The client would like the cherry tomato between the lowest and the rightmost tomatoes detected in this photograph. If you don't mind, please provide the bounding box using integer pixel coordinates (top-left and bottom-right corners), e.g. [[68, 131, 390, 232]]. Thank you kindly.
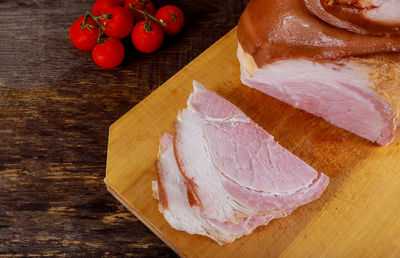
[[132, 21, 164, 53]]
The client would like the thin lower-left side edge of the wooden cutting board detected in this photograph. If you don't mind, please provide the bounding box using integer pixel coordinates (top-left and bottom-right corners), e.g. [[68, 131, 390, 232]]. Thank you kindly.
[[104, 177, 186, 257]]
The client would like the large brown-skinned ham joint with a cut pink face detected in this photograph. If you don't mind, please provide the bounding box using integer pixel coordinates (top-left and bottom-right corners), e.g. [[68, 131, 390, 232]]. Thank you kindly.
[[238, 0, 400, 145]]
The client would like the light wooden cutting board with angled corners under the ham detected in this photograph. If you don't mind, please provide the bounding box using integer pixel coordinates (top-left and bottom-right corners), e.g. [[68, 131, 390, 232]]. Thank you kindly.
[[105, 29, 400, 257]]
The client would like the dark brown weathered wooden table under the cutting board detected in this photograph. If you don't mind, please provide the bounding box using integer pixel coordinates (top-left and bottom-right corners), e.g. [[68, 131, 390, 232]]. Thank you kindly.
[[0, 0, 248, 257]]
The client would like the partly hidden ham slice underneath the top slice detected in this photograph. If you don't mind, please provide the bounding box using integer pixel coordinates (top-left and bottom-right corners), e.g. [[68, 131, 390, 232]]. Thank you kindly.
[[153, 133, 292, 245]]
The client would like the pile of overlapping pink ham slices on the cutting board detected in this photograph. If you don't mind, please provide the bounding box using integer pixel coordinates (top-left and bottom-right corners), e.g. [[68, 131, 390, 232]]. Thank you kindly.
[[153, 82, 329, 244]]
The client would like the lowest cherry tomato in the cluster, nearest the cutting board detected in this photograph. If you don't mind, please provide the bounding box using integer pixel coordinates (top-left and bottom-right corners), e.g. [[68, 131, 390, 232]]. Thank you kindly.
[[92, 38, 125, 69]]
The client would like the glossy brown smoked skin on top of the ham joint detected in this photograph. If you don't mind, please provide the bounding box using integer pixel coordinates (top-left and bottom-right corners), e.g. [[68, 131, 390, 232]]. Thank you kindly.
[[237, 0, 400, 65]]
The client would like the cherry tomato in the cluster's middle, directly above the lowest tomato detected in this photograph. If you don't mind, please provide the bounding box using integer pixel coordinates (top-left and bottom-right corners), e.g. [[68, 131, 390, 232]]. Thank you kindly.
[[101, 6, 134, 39]]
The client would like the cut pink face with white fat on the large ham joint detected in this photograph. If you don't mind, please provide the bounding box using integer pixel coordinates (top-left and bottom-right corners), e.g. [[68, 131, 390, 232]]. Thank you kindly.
[[238, 45, 395, 145]]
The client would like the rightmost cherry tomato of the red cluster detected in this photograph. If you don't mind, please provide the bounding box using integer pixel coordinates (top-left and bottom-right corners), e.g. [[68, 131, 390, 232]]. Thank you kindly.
[[156, 5, 185, 35]]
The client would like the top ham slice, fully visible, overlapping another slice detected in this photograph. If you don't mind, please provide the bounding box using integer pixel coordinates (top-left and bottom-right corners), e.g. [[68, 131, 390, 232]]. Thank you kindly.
[[173, 82, 329, 224]]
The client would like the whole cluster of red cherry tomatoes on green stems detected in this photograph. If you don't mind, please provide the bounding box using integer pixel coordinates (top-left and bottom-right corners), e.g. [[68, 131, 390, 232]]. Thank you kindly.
[[69, 0, 184, 68]]
